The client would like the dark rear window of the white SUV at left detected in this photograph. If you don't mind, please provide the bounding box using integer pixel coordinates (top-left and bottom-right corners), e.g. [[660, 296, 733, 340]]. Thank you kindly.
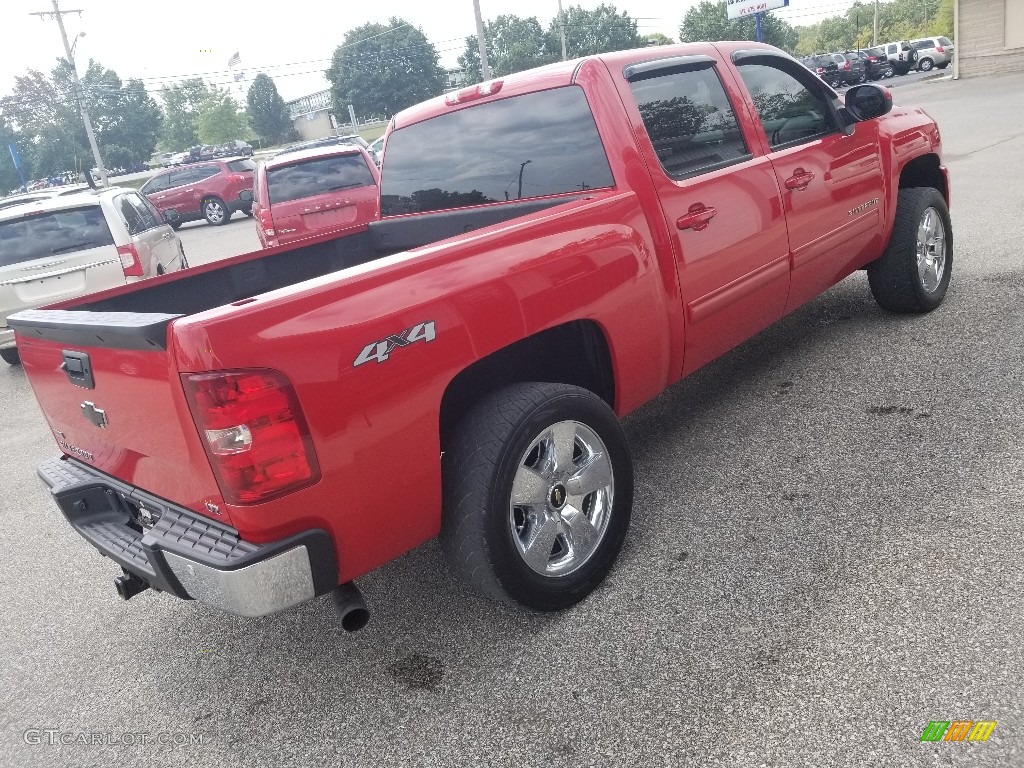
[[0, 206, 114, 266]]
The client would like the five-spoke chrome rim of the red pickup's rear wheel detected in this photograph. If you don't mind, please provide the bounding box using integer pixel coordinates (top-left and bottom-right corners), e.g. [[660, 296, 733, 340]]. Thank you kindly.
[[509, 421, 614, 577]]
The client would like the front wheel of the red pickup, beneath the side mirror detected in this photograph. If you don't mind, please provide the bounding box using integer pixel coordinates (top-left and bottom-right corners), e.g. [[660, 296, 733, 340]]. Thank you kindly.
[[867, 186, 953, 314]]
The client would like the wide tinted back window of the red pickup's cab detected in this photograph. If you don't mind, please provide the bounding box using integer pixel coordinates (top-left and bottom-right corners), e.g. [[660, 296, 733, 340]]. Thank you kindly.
[[381, 85, 614, 216]]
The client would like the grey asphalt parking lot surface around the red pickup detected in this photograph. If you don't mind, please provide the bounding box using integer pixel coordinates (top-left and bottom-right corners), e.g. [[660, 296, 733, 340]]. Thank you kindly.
[[0, 75, 1024, 768]]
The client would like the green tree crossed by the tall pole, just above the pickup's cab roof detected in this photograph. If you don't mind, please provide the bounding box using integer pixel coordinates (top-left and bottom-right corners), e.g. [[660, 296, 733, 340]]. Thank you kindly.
[[459, 15, 558, 83]]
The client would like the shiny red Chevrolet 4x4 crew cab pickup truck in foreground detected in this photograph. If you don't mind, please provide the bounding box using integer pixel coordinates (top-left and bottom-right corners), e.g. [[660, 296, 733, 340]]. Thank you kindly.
[[9, 43, 952, 630]]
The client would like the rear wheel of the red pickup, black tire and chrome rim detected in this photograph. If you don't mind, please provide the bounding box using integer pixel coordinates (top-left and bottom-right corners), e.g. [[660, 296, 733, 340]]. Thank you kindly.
[[440, 383, 633, 611]]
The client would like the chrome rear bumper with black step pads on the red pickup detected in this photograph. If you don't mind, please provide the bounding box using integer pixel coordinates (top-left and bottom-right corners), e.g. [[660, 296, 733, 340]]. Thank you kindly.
[[38, 458, 338, 616]]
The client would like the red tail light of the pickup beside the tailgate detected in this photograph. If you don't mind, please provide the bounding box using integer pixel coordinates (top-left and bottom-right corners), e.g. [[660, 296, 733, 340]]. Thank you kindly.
[[181, 370, 321, 504]]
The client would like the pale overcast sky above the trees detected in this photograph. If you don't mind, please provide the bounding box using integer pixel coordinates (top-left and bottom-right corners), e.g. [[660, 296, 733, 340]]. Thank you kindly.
[[0, 0, 852, 100]]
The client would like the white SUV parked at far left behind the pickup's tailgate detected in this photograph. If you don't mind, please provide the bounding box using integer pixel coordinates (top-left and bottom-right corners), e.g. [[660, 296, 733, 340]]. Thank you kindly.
[[0, 187, 188, 366]]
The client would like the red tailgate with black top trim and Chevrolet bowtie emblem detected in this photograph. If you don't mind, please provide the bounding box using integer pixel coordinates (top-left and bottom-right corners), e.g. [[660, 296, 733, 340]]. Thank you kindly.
[[8, 309, 229, 523]]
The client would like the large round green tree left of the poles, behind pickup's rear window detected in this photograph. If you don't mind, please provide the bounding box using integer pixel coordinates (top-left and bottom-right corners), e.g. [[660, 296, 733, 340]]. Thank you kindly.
[[325, 16, 444, 116]]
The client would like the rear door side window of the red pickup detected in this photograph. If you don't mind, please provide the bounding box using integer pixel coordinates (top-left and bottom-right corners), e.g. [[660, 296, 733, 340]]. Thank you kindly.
[[630, 68, 751, 180]]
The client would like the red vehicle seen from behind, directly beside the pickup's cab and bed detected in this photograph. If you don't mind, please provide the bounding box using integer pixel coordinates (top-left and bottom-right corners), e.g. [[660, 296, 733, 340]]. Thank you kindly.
[[253, 144, 380, 248]]
